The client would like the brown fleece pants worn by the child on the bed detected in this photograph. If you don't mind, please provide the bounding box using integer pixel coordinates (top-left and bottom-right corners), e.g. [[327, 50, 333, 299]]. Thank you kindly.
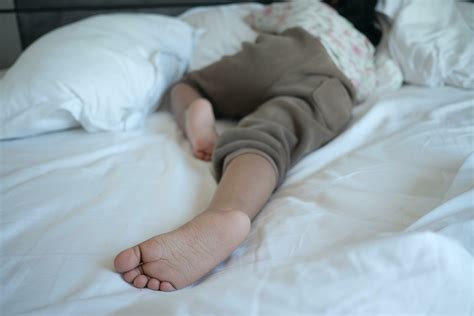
[[182, 28, 354, 184]]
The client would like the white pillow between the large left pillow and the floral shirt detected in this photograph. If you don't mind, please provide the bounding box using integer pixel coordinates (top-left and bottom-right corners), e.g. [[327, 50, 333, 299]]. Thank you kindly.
[[180, 3, 263, 71]]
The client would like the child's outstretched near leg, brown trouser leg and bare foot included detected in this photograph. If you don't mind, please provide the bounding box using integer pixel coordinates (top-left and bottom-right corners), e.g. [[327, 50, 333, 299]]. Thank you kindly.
[[115, 74, 352, 291]]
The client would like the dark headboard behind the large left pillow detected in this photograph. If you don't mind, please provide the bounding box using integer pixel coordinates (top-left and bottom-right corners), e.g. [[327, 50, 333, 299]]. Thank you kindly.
[[0, 0, 274, 69]]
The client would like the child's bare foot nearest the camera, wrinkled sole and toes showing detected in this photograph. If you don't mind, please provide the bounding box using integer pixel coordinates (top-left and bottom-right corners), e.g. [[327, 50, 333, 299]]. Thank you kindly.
[[114, 211, 250, 291]]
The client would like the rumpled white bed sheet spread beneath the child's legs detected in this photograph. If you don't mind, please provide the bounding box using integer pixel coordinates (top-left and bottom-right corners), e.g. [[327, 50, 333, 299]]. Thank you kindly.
[[0, 86, 474, 315]]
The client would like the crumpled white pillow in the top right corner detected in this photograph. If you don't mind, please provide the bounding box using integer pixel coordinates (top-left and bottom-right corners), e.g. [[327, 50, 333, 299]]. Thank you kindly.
[[377, 0, 474, 89]]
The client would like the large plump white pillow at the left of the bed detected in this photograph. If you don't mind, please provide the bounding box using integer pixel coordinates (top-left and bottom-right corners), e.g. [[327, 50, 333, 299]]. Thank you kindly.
[[0, 14, 196, 139]]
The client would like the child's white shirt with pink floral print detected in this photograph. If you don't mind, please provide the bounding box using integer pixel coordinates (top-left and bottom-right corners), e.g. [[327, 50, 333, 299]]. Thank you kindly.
[[248, 0, 376, 102]]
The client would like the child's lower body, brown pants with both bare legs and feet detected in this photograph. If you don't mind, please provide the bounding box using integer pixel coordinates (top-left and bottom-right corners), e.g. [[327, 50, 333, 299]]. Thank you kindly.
[[114, 0, 382, 291]]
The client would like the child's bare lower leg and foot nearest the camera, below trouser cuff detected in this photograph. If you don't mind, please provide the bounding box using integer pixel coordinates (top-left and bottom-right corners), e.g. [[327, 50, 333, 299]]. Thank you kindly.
[[114, 153, 277, 291]]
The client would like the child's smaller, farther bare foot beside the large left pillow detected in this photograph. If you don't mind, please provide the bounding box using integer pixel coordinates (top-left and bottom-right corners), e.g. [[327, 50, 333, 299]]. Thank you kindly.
[[184, 98, 217, 161]]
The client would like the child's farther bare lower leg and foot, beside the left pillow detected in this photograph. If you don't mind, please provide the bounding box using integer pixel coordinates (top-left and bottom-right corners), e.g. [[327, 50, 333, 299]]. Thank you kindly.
[[171, 83, 217, 160]]
